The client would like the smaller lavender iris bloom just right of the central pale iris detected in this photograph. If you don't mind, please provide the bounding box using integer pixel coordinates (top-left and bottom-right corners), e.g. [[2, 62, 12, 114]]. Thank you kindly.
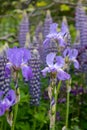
[[63, 48, 79, 69]]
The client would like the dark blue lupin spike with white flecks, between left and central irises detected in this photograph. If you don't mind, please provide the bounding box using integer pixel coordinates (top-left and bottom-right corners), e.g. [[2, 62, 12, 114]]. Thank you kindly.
[[29, 49, 41, 106]]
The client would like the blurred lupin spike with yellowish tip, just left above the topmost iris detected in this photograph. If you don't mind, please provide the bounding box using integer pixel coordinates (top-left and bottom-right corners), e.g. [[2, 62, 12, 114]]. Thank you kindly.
[[43, 10, 53, 39]]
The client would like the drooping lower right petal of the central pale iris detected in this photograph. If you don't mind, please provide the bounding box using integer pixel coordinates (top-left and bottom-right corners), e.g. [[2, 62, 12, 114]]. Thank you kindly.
[[57, 69, 70, 80]]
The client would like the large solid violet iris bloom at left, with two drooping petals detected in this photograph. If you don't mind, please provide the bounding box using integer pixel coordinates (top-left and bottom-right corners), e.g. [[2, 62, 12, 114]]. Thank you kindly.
[[5, 47, 32, 80]]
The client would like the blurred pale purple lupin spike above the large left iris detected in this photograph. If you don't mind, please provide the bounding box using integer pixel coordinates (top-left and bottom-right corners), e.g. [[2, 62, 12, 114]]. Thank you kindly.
[[18, 12, 29, 47]]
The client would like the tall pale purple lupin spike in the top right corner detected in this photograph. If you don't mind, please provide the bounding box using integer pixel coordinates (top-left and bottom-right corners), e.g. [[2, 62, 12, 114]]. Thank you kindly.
[[75, 2, 87, 45]]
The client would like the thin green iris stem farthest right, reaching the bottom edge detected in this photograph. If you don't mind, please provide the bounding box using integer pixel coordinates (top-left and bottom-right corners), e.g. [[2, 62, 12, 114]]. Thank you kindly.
[[66, 80, 70, 130]]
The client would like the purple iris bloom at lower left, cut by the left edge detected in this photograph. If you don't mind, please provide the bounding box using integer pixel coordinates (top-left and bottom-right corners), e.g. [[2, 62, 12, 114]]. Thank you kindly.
[[0, 89, 16, 116]]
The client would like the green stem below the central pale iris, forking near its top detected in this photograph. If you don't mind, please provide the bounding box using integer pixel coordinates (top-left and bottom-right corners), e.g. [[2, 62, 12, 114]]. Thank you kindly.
[[51, 81, 61, 130]]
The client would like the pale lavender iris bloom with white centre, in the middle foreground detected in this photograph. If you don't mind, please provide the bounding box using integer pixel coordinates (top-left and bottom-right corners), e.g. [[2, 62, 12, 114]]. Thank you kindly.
[[42, 53, 70, 80]]
